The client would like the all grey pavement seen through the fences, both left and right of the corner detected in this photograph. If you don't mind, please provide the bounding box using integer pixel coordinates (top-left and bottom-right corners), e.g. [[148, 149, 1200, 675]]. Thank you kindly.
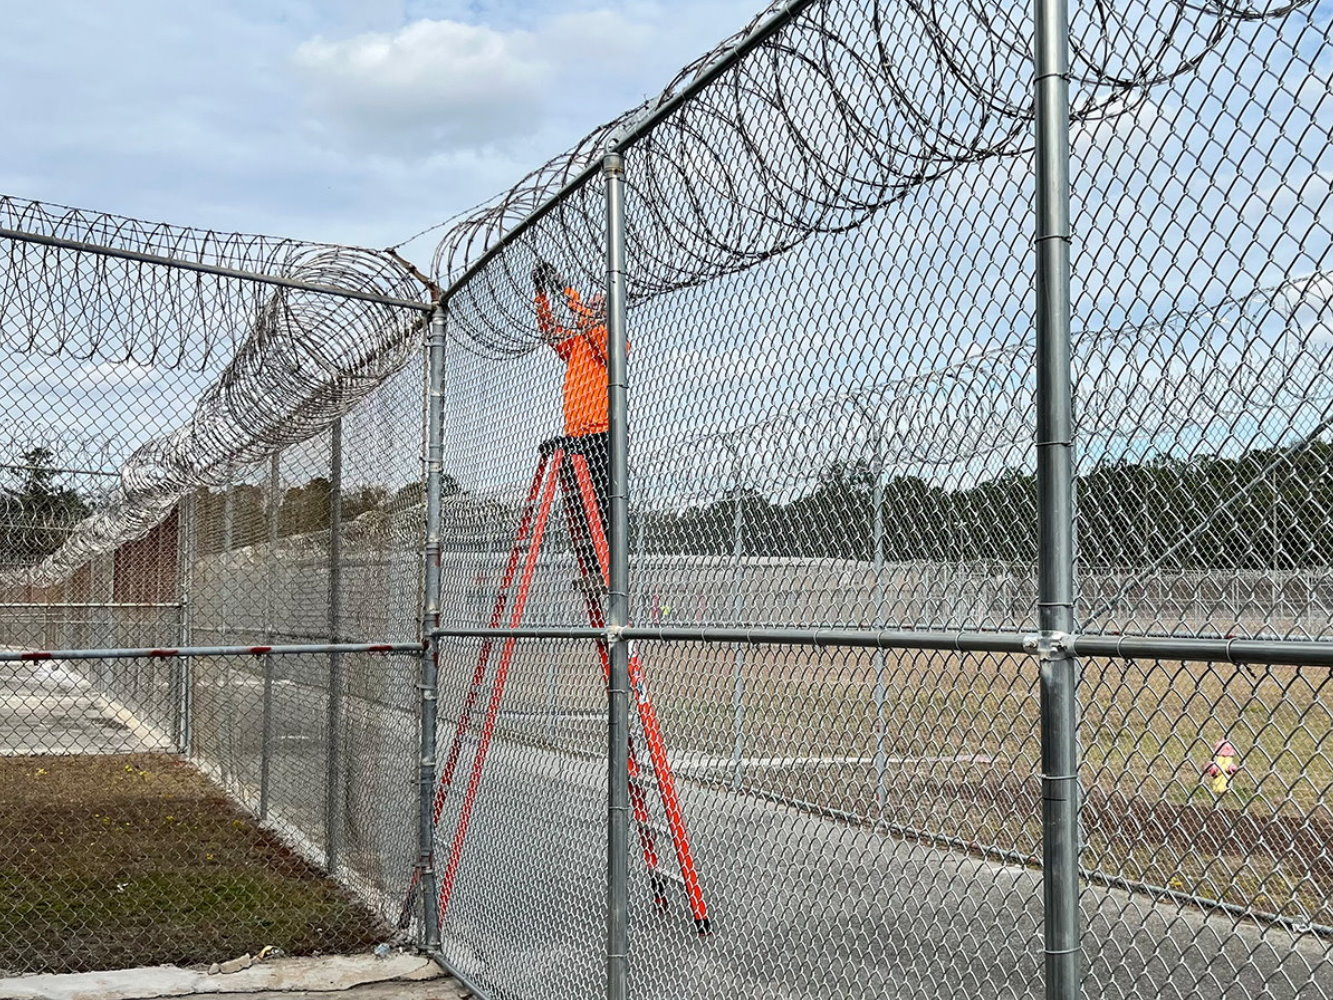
[[0, 657, 1333, 1000]]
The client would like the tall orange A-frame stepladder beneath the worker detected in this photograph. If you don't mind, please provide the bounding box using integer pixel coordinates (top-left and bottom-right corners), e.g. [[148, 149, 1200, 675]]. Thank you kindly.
[[399, 437, 709, 933]]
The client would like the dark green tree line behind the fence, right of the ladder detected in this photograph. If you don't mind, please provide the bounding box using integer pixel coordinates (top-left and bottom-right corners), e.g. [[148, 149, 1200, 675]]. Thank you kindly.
[[635, 441, 1333, 569]]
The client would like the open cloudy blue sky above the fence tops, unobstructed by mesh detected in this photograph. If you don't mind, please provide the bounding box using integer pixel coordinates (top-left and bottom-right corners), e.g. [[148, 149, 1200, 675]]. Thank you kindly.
[[0, 0, 761, 263]]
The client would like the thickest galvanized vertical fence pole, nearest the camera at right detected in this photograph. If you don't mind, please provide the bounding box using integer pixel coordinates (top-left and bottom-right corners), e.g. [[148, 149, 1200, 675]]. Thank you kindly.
[[1033, 0, 1082, 1000]]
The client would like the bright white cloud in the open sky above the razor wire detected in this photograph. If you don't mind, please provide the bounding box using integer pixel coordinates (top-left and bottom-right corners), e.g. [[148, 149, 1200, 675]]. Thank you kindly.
[[293, 0, 748, 157]]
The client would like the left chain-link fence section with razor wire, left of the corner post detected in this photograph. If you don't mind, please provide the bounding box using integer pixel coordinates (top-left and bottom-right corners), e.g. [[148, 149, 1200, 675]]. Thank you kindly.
[[0, 199, 424, 975]]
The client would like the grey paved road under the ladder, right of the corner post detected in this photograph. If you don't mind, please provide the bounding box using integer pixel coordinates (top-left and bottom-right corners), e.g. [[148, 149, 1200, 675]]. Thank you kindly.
[[440, 741, 1333, 1000]]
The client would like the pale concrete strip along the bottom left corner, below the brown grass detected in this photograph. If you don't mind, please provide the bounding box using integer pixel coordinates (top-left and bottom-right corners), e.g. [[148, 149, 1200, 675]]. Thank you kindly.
[[0, 953, 471, 1000]]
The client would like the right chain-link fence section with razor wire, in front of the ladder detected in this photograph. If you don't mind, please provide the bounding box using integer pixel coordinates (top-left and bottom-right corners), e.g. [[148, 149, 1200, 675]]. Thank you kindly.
[[418, 1, 1333, 999]]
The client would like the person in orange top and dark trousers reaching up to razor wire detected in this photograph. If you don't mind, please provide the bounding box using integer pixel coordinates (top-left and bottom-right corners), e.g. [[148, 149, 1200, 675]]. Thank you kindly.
[[532, 263, 611, 596]]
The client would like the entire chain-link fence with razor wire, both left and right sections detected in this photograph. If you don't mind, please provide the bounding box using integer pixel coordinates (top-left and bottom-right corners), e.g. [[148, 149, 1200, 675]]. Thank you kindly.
[[0, 0, 1333, 1000]]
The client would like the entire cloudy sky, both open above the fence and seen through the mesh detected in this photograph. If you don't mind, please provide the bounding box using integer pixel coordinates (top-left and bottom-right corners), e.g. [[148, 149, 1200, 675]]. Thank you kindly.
[[0, 0, 1333, 594]]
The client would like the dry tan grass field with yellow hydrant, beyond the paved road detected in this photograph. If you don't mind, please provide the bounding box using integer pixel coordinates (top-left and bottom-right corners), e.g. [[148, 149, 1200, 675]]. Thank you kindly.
[[461, 643, 1333, 924]]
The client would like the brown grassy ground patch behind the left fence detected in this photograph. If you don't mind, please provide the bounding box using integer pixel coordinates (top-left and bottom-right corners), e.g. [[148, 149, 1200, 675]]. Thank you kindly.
[[0, 753, 389, 975]]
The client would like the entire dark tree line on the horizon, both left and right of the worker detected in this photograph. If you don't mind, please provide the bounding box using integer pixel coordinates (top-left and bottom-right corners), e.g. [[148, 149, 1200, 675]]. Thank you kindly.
[[0, 441, 1333, 569]]
